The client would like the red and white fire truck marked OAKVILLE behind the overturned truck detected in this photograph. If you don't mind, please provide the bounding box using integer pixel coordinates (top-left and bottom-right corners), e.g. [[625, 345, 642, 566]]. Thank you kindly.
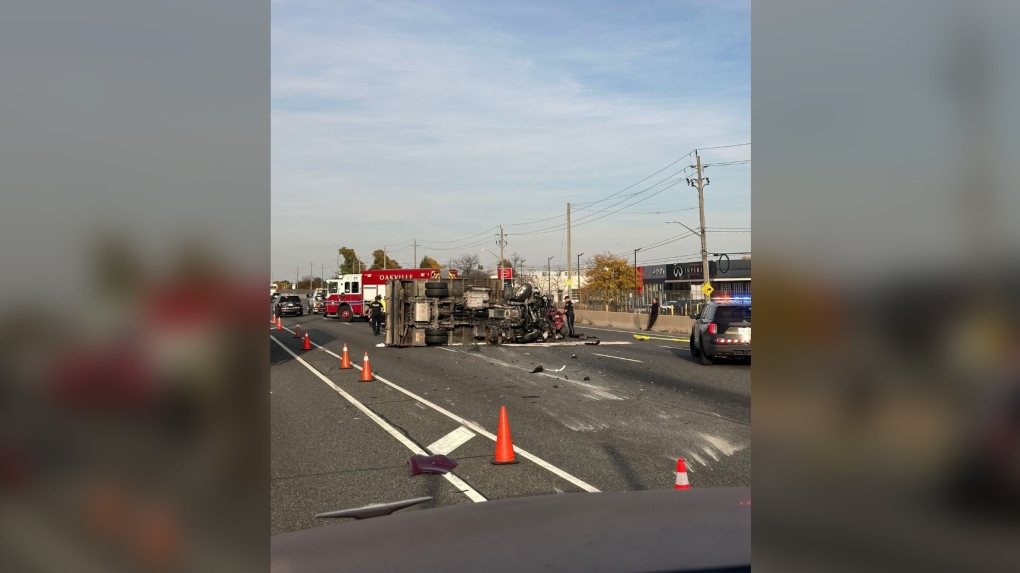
[[322, 268, 457, 322]]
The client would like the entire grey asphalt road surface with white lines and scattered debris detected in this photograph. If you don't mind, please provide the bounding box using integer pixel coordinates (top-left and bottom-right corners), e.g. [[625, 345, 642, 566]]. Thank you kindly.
[[269, 315, 751, 534]]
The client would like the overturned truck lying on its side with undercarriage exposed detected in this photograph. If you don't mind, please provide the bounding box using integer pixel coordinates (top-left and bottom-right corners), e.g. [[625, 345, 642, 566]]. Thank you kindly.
[[386, 278, 568, 347]]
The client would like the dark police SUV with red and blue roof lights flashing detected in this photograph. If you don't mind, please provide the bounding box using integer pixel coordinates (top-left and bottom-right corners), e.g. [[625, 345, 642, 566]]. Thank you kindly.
[[691, 301, 751, 366]]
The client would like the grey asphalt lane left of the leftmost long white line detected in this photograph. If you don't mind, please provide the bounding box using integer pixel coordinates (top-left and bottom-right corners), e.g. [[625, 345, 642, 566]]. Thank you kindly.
[[269, 331, 470, 534]]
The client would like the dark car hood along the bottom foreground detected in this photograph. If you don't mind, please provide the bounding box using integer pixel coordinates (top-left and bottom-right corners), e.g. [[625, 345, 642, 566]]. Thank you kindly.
[[270, 487, 751, 573]]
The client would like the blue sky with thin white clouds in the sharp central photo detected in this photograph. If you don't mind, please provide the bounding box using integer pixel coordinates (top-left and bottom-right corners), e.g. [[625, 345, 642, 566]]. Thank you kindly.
[[271, 0, 751, 278]]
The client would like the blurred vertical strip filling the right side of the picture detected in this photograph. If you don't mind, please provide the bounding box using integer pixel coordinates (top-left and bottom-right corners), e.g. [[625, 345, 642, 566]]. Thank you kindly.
[[753, 0, 1020, 571]]
